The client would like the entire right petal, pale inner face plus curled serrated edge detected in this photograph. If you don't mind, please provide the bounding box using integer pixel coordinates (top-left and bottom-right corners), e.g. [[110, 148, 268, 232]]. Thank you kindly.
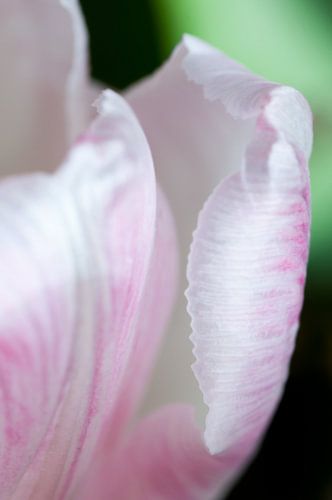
[[128, 36, 312, 498]]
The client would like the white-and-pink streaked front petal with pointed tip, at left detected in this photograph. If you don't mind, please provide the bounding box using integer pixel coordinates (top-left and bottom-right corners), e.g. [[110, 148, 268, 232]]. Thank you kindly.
[[0, 91, 167, 500]]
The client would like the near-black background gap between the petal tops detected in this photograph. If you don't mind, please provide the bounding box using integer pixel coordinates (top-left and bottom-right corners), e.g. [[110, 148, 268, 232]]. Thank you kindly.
[[80, 0, 161, 89]]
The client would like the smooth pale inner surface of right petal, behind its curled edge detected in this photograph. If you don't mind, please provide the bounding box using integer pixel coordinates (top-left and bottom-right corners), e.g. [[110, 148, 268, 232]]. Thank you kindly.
[[126, 36, 273, 421]]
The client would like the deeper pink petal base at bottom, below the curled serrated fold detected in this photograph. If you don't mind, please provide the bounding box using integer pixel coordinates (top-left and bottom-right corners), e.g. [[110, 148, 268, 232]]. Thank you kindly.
[[88, 405, 232, 500]]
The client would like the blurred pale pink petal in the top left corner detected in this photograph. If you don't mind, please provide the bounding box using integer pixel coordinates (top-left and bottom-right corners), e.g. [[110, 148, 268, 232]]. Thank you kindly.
[[0, 0, 91, 175]]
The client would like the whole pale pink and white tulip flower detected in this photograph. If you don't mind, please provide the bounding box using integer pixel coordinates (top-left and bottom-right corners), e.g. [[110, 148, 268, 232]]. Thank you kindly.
[[0, 0, 312, 500]]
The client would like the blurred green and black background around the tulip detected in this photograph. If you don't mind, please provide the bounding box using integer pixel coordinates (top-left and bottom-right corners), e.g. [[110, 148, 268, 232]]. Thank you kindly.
[[81, 0, 332, 500]]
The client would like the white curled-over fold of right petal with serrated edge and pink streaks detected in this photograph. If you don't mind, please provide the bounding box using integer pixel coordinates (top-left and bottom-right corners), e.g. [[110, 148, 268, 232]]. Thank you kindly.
[[187, 84, 310, 453]]
